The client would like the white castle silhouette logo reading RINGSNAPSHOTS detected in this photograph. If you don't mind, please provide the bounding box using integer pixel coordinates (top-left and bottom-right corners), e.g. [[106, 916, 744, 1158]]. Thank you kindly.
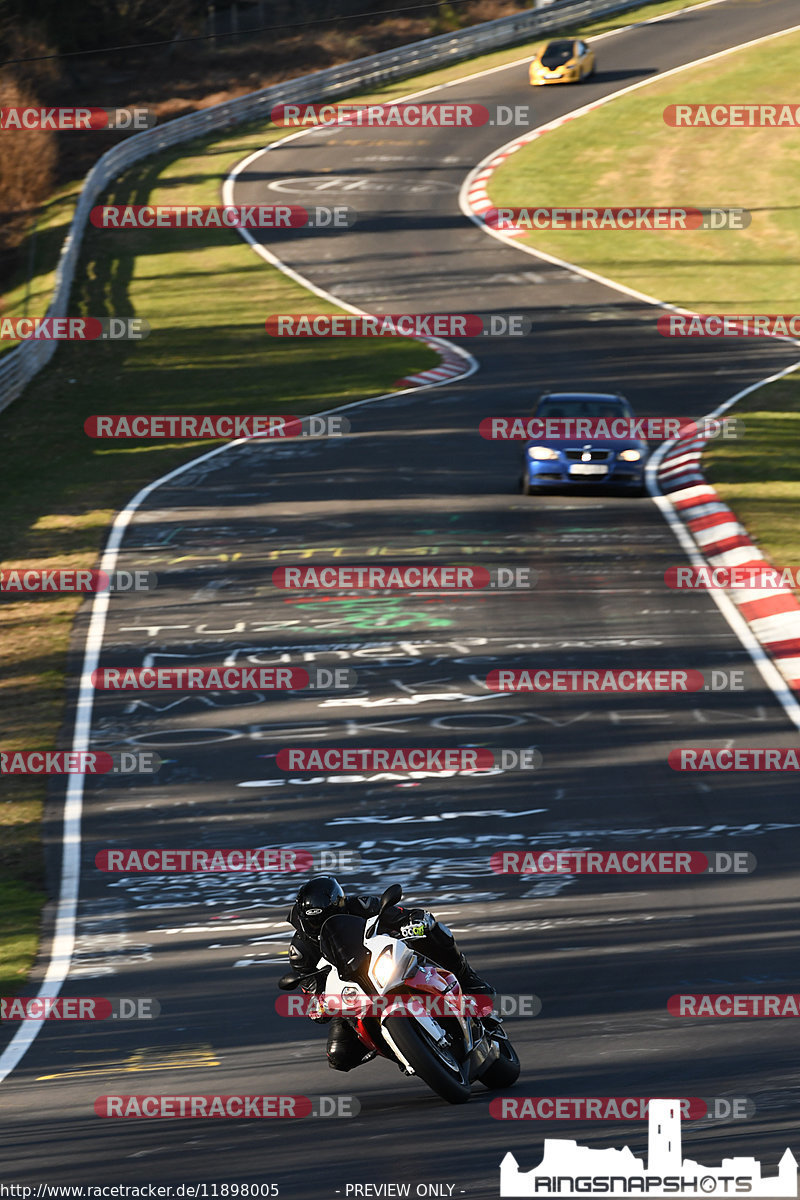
[[500, 1099, 798, 1200]]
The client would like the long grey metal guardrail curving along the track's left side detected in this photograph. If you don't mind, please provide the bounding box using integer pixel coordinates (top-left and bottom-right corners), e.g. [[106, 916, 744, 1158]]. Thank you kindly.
[[0, 0, 657, 412]]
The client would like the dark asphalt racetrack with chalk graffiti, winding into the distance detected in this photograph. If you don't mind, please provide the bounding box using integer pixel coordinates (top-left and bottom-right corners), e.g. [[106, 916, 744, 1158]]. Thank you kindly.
[[0, 0, 800, 1200]]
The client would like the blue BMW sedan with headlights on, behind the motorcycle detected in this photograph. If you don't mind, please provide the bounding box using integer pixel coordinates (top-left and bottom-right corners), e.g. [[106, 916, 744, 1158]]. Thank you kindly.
[[522, 391, 649, 496]]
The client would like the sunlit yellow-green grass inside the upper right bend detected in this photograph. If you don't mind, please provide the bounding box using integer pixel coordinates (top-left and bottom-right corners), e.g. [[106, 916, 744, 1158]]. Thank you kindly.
[[489, 34, 800, 313]]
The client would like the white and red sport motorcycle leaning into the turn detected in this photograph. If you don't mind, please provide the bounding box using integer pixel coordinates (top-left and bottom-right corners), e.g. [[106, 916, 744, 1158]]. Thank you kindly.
[[278, 883, 521, 1104]]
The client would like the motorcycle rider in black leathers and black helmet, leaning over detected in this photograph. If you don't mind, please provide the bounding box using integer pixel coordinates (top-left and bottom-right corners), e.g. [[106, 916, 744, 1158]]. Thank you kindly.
[[287, 875, 494, 1070]]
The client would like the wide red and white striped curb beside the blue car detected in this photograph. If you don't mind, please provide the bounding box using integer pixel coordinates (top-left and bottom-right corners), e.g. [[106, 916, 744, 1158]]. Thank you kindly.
[[656, 434, 800, 691]]
